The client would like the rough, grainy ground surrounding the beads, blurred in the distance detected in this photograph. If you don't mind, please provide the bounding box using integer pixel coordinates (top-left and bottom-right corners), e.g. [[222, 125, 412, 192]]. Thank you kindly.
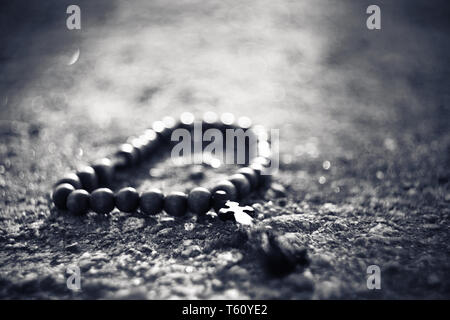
[[0, 0, 450, 299]]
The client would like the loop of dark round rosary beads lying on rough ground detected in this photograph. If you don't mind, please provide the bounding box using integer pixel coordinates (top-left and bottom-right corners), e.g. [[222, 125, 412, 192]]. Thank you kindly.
[[52, 112, 270, 217]]
